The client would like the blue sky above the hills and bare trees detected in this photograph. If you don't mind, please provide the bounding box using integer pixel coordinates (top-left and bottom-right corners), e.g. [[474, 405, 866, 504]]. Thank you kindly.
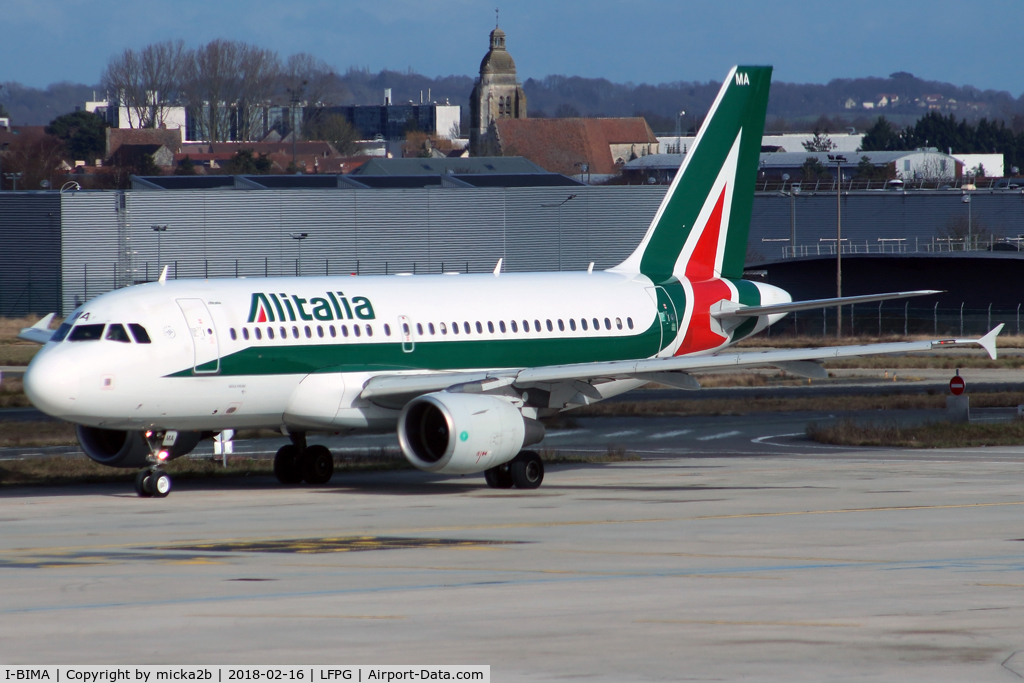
[[6, 0, 1024, 96]]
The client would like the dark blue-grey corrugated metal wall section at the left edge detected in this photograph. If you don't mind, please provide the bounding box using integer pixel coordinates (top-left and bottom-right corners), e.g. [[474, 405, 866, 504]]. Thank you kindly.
[[0, 191, 60, 316]]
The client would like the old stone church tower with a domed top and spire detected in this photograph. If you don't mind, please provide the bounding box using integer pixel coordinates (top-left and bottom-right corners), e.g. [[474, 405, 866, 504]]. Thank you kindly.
[[469, 26, 526, 157]]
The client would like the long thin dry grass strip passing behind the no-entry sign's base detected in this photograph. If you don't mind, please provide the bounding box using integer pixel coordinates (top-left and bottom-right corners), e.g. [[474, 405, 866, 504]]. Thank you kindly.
[[572, 391, 1024, 418]]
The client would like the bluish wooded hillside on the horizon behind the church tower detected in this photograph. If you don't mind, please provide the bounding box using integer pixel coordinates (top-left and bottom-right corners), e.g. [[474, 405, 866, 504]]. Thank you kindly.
[[0, 70, 1024, 133]]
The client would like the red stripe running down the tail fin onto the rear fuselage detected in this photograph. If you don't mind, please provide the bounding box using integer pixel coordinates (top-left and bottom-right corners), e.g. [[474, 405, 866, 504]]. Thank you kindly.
[[676, 186, 732, 355]]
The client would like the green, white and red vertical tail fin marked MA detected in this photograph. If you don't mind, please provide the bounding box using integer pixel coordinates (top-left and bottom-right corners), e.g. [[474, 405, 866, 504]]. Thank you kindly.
[[612, 67, 772, 282]]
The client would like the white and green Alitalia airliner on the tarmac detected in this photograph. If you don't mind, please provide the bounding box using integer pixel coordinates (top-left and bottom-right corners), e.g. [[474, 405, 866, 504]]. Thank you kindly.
[[20, 67, 1001, 497]]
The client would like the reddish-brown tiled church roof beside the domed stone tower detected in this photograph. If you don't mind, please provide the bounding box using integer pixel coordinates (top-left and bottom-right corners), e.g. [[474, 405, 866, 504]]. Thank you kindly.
[[495, 117, 657, 175]]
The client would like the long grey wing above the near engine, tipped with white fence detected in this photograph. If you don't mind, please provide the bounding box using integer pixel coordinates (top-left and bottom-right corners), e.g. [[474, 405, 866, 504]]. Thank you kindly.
[[359, 325, 1004, 405]]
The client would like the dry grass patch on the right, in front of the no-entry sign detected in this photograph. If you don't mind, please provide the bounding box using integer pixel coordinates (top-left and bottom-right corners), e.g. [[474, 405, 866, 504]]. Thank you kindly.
[[807, 420, 1024, 449]]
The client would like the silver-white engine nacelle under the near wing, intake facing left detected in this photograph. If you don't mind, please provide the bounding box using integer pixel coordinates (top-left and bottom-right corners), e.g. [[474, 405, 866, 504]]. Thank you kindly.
[[398, 391, 544, 474]]
